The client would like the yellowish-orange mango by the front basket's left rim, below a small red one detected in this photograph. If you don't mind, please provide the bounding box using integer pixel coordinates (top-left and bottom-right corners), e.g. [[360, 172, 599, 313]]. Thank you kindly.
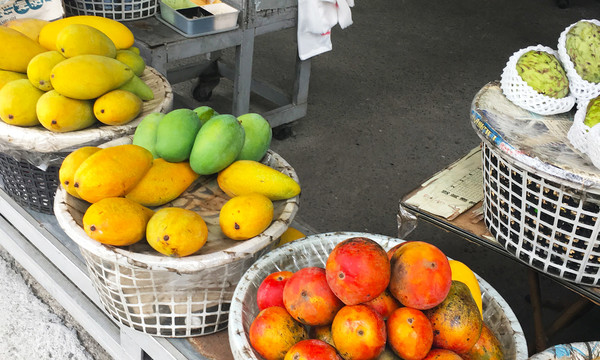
[[248, 306, 308, 360]]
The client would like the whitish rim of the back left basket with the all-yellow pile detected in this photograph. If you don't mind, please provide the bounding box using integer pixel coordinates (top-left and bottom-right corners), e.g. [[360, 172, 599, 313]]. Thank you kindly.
[[0, 66, 174, 153]]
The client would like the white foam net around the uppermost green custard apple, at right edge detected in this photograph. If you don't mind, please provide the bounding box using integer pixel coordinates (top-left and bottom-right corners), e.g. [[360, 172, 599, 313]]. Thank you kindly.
[[558, 20, 600, 101]]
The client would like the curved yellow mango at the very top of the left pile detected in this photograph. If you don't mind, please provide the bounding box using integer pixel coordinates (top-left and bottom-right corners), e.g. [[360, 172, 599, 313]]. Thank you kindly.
[[39, 15, 134, 50]]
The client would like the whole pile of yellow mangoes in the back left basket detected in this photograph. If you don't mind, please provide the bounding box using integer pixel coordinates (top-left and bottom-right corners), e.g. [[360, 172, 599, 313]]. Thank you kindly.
[[0, 15, 154, 132]]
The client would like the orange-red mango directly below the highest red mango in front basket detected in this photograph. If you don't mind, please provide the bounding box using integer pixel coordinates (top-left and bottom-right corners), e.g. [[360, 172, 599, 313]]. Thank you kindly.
[[331, 304, 387, 360]]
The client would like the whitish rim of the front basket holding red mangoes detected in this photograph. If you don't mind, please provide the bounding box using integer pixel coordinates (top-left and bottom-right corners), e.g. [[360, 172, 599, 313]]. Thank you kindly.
[[227, 231, 528, 359]]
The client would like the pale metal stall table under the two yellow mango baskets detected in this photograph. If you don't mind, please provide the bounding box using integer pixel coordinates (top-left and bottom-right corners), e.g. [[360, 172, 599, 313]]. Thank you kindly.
[[0, 189, 313, 360]]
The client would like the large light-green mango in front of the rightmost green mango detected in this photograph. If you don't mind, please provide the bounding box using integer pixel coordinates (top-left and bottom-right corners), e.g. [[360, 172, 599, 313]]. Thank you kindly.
[[190, 115, 245, 175]]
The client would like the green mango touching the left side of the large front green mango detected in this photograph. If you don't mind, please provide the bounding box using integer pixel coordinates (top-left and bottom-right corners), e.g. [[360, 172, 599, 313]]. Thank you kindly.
[[156, 109, 202, 162]]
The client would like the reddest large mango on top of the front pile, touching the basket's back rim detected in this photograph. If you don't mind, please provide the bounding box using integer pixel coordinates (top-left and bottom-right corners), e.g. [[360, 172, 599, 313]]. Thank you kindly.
[[325, 237, 390, 305]]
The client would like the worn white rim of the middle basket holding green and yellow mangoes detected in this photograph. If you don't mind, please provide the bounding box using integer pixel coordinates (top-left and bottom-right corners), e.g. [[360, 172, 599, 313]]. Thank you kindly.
[[54, 150, 300, 273]]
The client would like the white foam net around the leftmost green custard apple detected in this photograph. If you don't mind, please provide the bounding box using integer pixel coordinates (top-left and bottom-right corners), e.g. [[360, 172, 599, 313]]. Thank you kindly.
[[500, 45, 575, 115]]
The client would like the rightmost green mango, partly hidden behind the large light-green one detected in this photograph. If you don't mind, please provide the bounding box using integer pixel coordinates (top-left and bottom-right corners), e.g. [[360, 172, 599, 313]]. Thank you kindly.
[[236, 113, 273, 161]]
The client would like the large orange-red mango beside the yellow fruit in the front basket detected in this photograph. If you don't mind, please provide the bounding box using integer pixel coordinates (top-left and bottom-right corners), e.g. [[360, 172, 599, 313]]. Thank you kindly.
[[389, 241, 452, 310]]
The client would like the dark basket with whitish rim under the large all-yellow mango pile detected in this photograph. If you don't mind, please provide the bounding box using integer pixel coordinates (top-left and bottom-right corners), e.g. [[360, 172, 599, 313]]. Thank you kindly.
[[0, 67, 173, 214]]
